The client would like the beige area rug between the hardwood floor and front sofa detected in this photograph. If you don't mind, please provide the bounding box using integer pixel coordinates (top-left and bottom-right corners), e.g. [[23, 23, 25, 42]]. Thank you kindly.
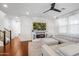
[[28, 41, 42, 56]]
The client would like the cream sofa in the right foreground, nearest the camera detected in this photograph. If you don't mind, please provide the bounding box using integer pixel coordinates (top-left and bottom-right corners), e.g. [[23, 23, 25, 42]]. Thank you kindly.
[[42, 43, 79, 56]]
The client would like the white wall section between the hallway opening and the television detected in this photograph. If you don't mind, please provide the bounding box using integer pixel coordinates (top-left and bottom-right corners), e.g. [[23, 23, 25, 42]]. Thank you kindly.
[[20, 17, 32, 41]]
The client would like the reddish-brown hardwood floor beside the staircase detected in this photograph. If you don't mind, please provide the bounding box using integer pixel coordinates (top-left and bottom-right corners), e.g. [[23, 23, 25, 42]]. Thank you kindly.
[[0, 37, 28, 56]]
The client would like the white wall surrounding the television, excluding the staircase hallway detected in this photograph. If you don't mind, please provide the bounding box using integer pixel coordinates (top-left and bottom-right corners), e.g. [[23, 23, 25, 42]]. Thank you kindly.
[[20, 17, 54, 41]]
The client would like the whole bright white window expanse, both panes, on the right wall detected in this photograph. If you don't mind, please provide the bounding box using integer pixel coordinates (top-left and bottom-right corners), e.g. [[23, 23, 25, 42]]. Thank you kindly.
[[56, 14, 79, 34]]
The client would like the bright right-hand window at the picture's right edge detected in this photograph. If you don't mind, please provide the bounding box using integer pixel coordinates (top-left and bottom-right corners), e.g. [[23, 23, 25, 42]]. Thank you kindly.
[[68, 14, 79, 34]]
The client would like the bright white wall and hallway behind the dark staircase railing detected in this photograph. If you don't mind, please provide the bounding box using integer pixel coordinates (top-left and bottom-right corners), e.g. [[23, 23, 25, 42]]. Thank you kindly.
[[0, 11, 20, 38]]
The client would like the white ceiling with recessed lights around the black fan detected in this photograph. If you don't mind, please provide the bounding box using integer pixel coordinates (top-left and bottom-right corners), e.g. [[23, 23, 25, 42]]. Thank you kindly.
[[0, 3, 79, 17]]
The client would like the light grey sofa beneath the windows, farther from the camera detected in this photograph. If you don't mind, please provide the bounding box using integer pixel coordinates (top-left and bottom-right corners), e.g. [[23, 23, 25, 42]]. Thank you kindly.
[[53, 35, 79, 43]]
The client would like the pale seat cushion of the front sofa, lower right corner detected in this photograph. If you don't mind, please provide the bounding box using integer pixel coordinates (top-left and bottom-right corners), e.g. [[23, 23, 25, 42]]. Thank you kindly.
[[58, 43, 79, 56]]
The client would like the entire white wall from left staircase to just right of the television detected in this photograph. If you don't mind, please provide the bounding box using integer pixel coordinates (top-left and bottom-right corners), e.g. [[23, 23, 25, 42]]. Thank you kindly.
[[0, 12, 55, 41]]
